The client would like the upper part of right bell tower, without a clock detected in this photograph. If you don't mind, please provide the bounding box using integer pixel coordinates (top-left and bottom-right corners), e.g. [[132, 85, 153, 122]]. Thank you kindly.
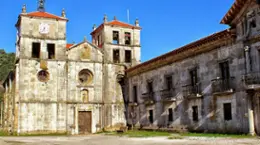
[[91, 15, 141, 68]]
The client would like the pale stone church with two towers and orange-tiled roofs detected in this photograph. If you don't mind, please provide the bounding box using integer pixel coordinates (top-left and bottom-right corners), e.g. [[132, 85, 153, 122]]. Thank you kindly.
[[2, 0, 141, 134]]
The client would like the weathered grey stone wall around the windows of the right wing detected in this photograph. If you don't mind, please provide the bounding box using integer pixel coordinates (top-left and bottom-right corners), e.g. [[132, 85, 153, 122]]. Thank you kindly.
[[128, 43, 248, 133]]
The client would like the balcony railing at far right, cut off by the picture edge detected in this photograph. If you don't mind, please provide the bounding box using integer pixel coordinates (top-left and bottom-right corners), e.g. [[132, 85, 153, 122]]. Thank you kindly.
[[244, 72, 260, 88]]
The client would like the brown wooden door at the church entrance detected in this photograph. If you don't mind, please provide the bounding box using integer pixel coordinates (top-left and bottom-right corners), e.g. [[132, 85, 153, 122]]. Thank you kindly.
[[79, 111, 92, 134]]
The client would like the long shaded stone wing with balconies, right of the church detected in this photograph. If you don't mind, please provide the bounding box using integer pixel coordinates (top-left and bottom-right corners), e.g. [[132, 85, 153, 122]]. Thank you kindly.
[[126, 0, 260, 135]]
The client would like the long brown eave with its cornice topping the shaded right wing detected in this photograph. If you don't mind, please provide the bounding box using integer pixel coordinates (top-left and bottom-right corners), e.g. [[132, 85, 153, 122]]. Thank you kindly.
[[126, 29, 232, 76]]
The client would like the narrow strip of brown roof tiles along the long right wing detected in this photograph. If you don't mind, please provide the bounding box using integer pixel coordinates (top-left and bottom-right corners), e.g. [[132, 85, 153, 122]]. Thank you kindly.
[[126, 30, 231, 76]]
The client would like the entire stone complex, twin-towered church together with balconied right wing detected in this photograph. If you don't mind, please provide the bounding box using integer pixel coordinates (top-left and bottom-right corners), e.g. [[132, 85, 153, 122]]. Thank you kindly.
[[2, 0, 260, 135]]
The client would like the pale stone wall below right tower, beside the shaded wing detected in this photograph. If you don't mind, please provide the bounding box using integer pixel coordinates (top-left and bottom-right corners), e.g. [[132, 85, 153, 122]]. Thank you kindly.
[[103, 64, 126, 128]]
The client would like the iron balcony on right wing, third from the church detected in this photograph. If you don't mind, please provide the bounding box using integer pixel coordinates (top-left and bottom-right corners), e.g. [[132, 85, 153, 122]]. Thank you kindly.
[[182, 83, 201, 98]]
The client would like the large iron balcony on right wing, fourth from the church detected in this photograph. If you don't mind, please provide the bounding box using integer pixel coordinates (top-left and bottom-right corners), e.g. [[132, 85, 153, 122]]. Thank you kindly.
[[212, 77, 235, 93]]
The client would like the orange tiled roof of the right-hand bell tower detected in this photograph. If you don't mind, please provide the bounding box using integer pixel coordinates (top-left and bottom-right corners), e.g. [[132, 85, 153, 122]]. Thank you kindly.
[[91, 20, 141, 35]]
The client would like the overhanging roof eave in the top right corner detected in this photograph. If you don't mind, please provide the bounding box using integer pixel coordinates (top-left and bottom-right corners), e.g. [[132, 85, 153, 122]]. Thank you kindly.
[[220, 0, 248, 24]]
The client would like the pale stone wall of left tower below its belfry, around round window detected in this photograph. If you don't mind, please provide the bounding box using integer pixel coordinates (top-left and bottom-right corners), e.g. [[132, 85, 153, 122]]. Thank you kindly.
[[19, 59, 67, 132]]
